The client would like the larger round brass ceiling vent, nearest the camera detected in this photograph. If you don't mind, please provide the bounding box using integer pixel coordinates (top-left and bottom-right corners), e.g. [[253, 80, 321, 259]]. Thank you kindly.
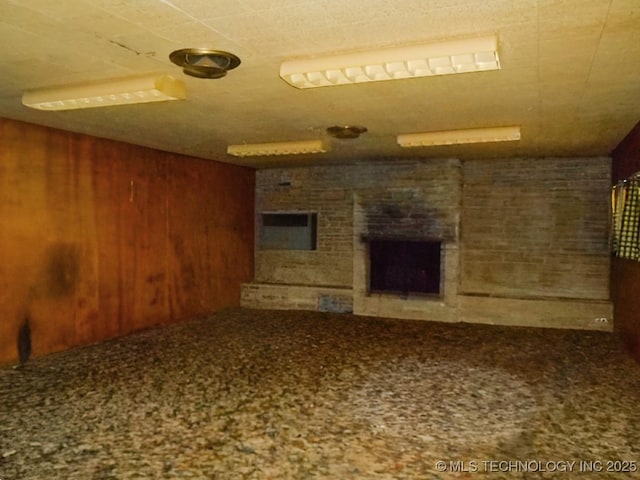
[[169, 48, 240, 78]]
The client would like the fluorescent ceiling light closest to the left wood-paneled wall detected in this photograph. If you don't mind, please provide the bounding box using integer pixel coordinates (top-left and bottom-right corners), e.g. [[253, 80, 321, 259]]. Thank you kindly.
[[22, 75, 187, 111]]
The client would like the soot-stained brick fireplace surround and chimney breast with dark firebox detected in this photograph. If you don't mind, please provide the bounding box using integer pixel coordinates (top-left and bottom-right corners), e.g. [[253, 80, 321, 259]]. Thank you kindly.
[[353, 167, 462, 321]]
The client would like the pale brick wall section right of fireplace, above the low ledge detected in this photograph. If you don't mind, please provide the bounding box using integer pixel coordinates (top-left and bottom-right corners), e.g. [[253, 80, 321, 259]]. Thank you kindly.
[[460, 158, 611, 300]]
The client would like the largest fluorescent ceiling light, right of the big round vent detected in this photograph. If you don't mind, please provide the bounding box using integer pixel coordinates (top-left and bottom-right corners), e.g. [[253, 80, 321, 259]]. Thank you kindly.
[[280, 35, 500, 88]]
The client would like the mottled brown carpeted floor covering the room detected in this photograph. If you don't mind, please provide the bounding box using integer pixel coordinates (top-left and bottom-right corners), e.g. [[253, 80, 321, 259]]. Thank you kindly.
[[0, 309, 640, 480]]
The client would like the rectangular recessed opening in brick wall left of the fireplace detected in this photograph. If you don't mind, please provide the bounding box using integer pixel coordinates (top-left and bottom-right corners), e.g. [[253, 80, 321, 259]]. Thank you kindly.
[[259, 213, 318, 250]]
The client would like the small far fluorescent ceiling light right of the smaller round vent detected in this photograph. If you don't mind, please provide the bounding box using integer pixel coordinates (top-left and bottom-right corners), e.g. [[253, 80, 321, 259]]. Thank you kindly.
[[397, 127, 520, 147]]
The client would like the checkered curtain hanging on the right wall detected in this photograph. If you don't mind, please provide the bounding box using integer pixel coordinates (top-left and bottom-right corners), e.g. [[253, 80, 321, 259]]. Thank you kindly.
[[611, 175, 640, 261]]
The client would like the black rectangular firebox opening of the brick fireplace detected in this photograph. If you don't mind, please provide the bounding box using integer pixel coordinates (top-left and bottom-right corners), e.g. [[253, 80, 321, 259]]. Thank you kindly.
[[369, 240, 441, 296]]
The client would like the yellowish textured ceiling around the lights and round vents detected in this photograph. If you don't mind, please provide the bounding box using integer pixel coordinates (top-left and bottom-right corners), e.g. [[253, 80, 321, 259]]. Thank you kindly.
[[0, 0, 640, 167]]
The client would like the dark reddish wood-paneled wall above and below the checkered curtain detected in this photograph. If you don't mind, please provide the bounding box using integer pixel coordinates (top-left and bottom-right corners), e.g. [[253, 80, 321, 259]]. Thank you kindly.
[[611, 123, 640, 362]]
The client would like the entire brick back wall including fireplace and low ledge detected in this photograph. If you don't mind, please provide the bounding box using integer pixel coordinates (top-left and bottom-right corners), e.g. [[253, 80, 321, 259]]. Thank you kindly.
[[242, 158, 612, 330]]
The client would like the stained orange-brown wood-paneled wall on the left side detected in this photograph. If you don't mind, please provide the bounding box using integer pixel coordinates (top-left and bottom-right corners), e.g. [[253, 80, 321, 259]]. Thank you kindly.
[[0, 119, 255, 364]]
